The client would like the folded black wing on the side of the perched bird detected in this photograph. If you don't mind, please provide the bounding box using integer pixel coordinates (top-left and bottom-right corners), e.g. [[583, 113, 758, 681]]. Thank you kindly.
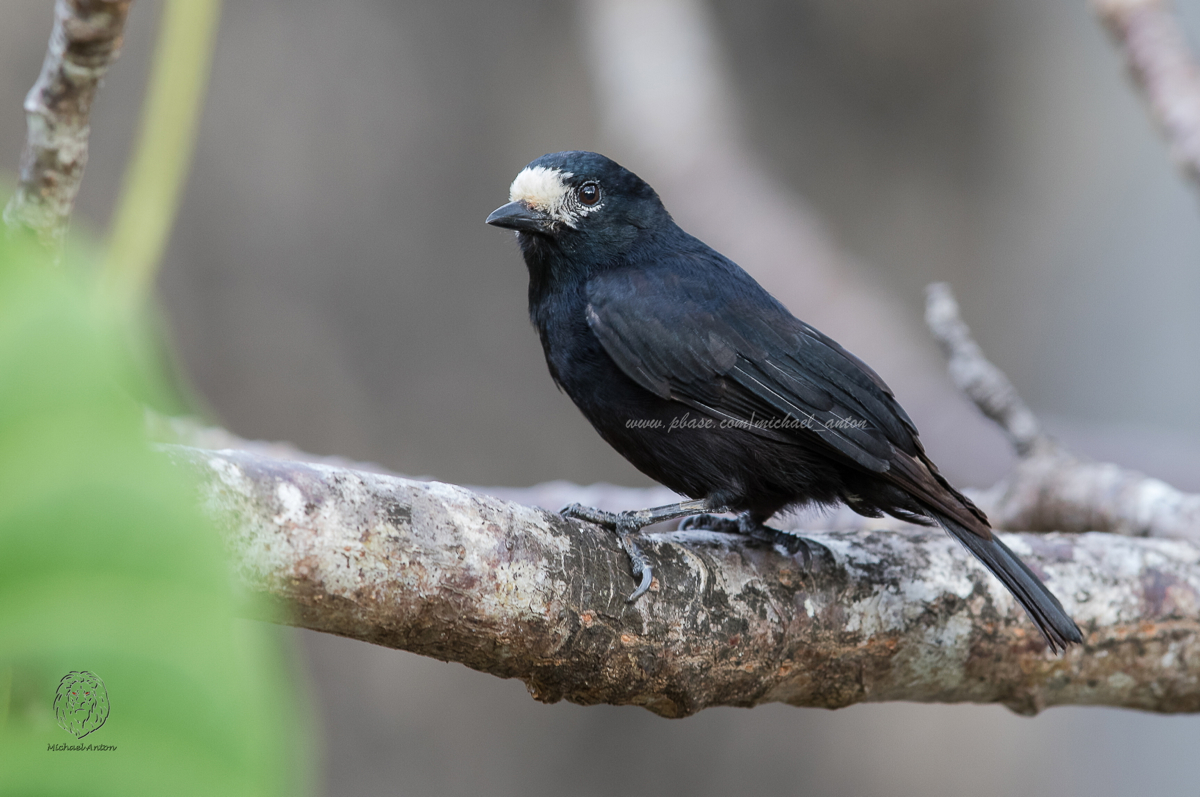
[[587, 256, 920, 473]]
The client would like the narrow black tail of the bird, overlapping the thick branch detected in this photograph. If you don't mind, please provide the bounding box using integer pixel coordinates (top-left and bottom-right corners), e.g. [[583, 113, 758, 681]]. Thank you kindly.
[[934, 513, 1084, 653]]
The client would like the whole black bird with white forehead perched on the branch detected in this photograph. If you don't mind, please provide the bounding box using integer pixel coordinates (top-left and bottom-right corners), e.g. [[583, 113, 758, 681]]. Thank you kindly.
[[487, 151, 1081, 652]]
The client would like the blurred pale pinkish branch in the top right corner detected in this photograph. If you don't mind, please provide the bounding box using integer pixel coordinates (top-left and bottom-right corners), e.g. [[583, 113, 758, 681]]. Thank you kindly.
[[1092, 0, 1200, 182]]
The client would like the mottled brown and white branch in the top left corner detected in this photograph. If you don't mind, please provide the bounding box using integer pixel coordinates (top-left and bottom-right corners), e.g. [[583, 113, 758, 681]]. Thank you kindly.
[[4, 0, 132, 251]]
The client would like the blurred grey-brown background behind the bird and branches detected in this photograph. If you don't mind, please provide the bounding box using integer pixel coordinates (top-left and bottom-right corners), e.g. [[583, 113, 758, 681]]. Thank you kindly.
[[0, 0, 1200, 796]]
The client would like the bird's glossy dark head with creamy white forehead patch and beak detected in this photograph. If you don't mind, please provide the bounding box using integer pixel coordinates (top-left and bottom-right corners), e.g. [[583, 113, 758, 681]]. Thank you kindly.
[[487, 151, 670, 267]]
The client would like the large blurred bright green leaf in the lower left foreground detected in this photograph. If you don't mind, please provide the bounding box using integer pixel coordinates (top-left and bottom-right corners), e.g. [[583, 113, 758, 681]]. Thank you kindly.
[[0, 235, 311, 795]]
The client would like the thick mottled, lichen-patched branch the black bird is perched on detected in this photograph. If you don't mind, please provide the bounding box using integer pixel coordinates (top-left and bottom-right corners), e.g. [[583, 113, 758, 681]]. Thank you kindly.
[[169, 448, 1200, 717]]
